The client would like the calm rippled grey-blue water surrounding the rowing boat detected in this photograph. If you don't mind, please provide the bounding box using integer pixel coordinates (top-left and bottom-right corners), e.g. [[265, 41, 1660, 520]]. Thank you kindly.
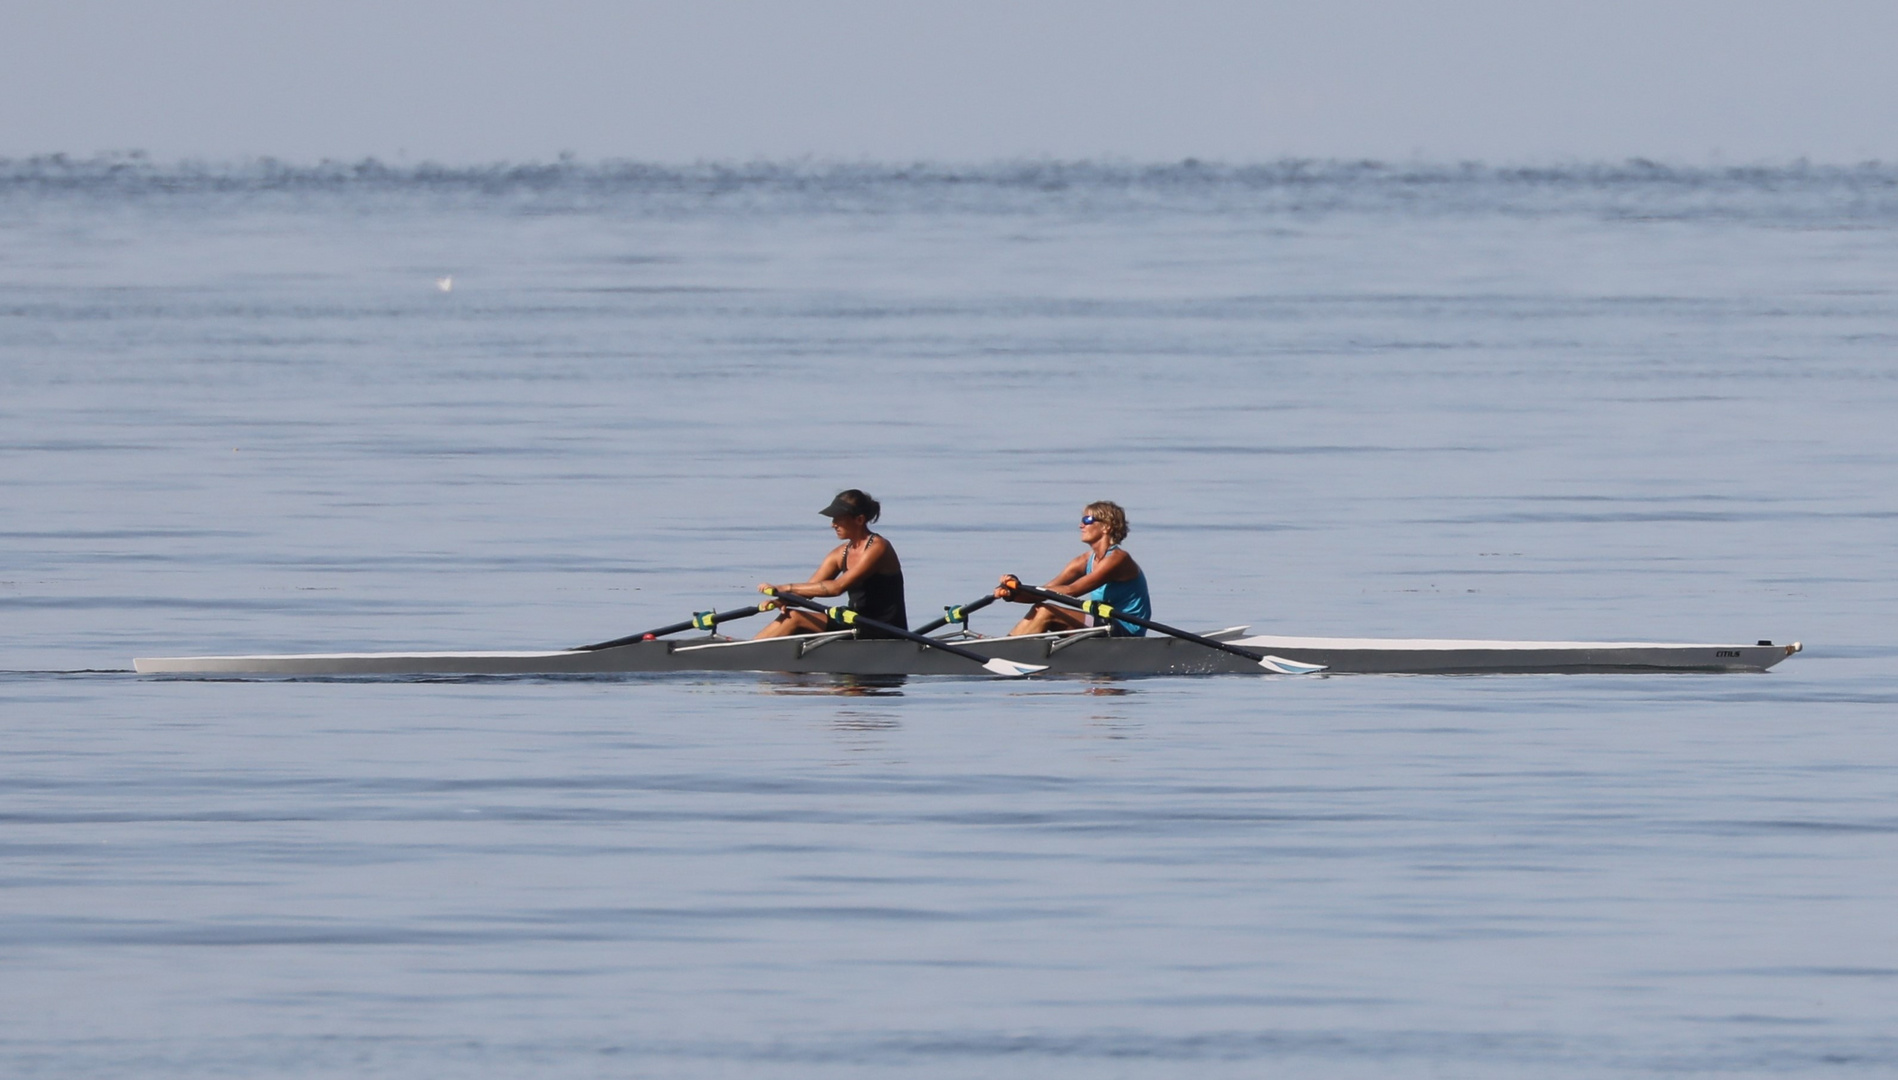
[[0, 159, 1898, 1078]]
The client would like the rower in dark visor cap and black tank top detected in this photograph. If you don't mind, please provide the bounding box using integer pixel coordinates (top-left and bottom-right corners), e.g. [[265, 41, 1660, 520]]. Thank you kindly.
[[757, 488, 909, 638]]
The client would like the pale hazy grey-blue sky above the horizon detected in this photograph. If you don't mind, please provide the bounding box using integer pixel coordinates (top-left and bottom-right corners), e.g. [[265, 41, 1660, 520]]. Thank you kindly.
[[0, 0, 1898, 163]]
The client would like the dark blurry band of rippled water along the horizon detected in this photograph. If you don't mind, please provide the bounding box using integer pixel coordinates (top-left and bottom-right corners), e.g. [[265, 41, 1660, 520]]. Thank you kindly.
[[0, 152, 1898, 205]]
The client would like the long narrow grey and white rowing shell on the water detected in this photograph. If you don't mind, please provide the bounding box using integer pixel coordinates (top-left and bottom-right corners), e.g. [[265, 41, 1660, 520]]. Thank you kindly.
[[133, 626, 1799, 676]]
